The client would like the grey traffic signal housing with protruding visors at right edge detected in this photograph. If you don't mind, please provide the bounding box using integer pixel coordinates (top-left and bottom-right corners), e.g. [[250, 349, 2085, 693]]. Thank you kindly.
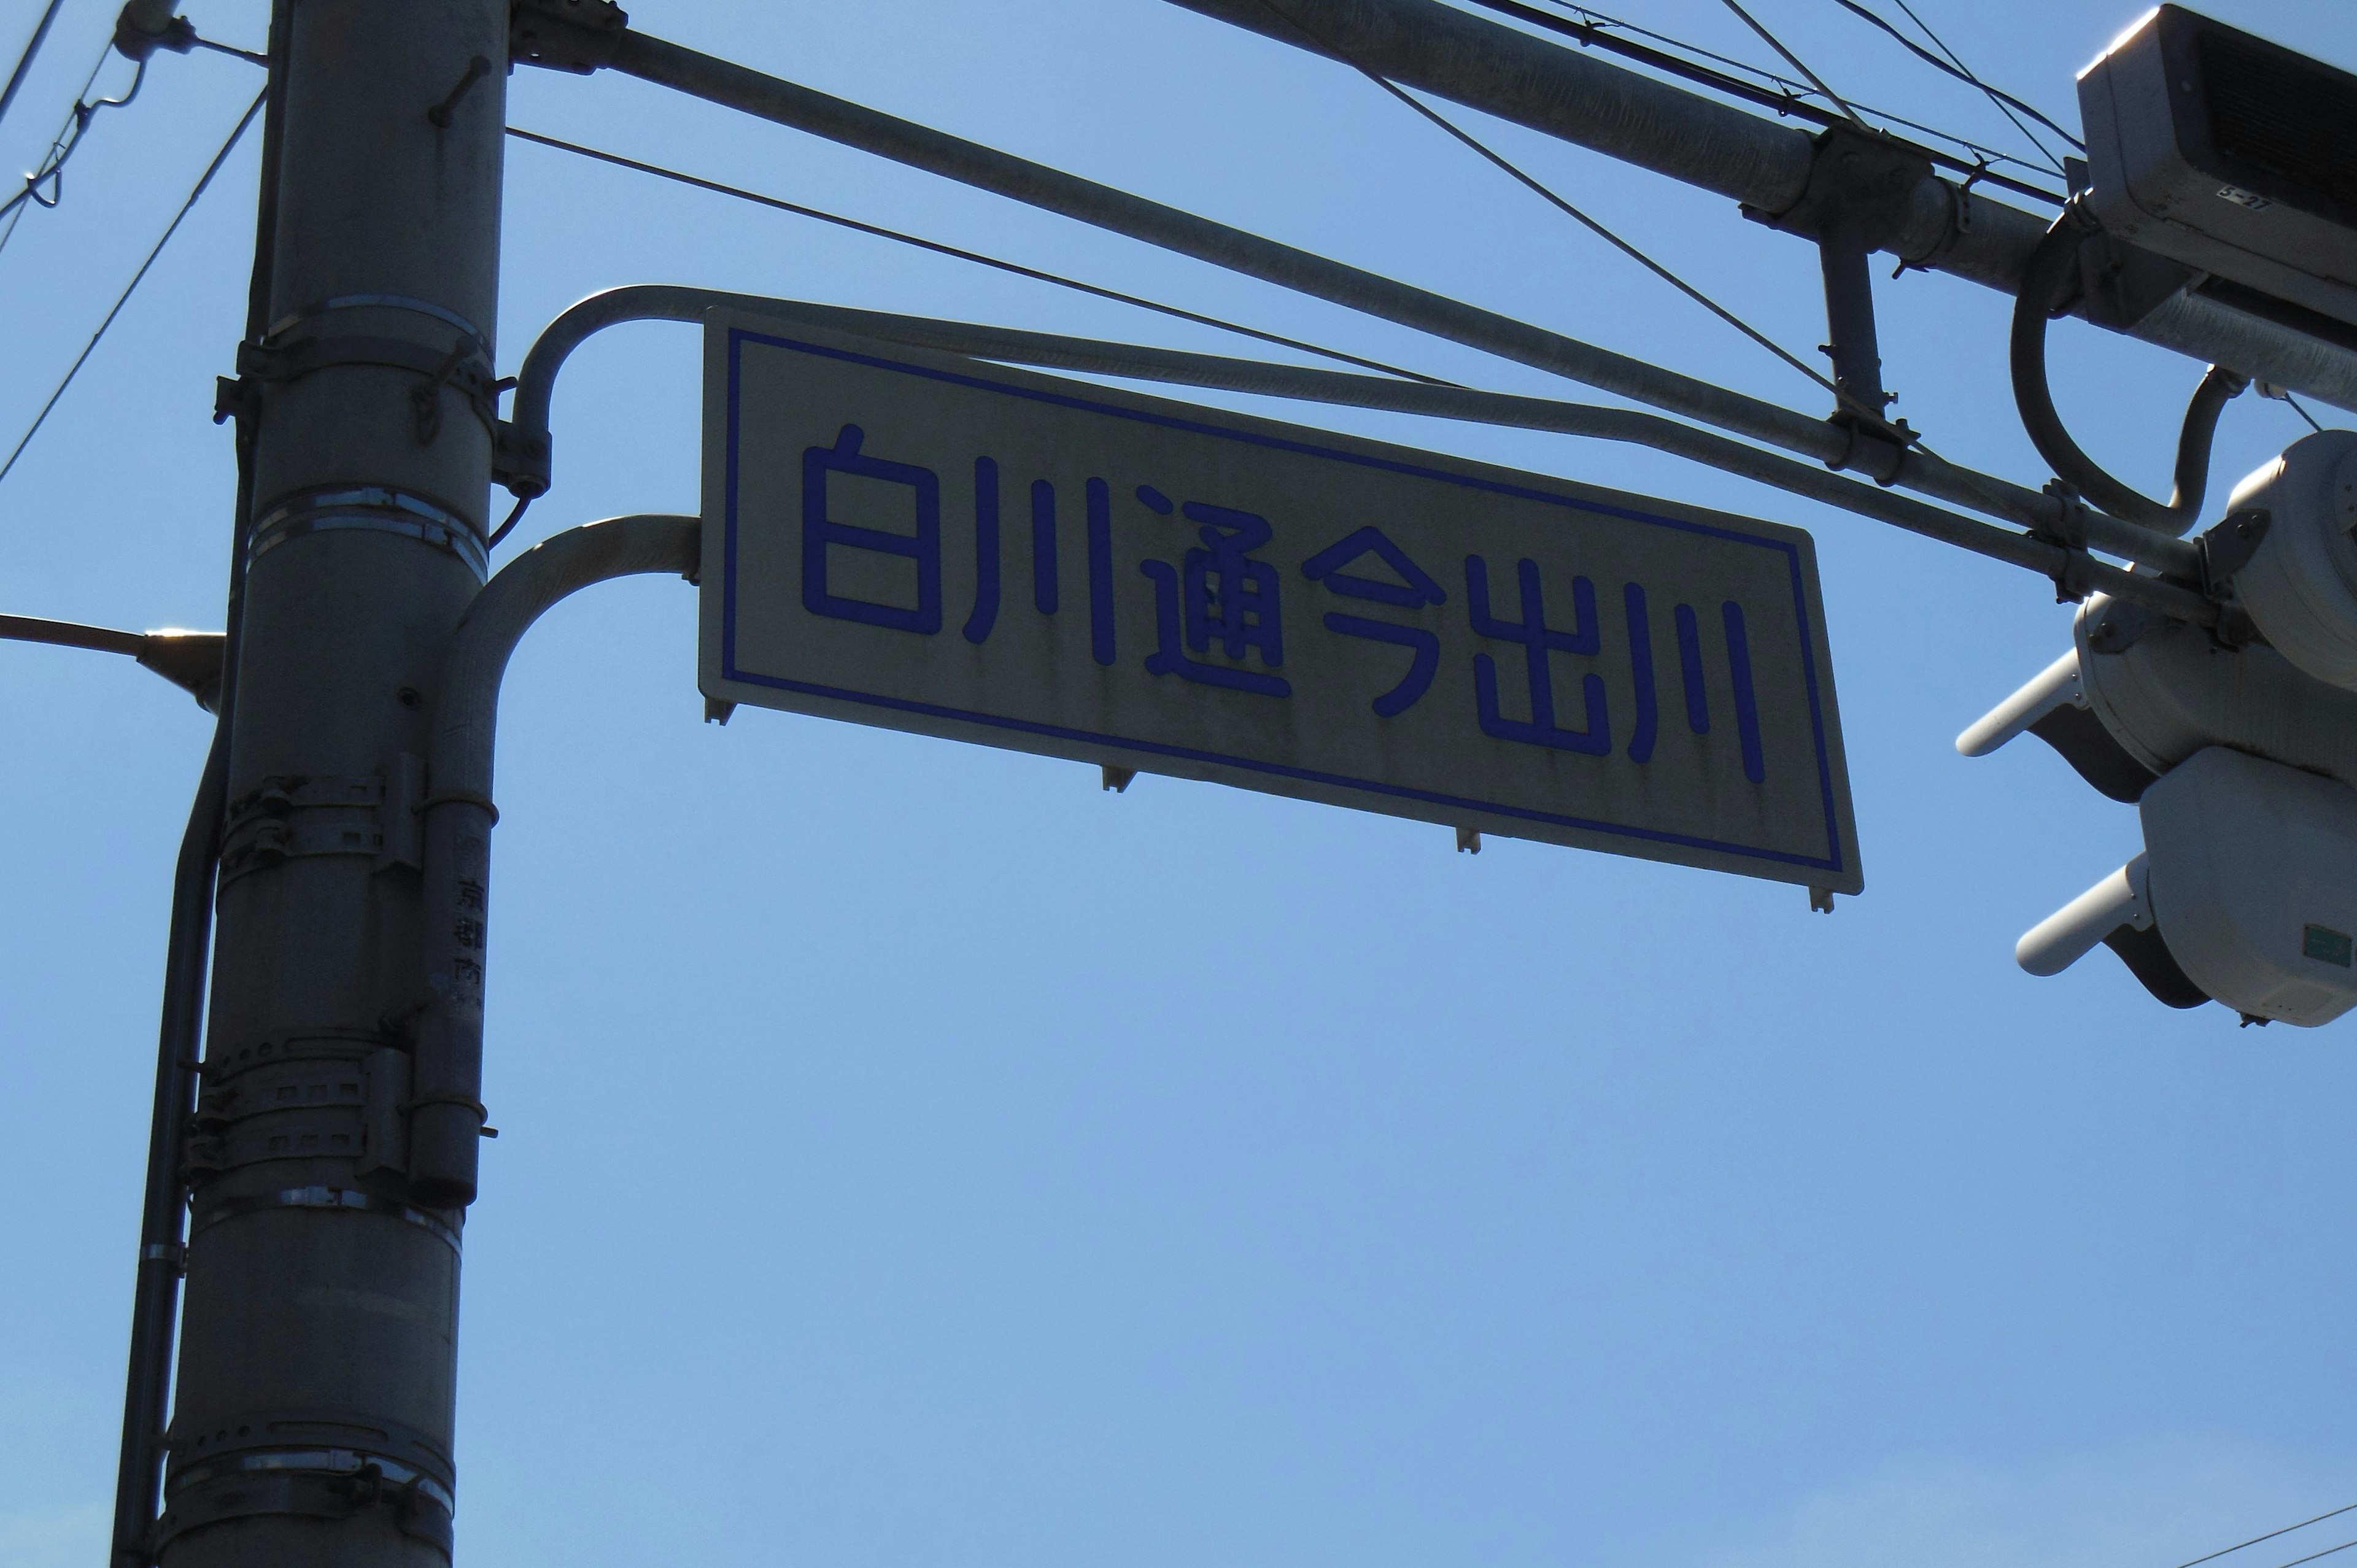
[[1956, 431, 2357, 1025]]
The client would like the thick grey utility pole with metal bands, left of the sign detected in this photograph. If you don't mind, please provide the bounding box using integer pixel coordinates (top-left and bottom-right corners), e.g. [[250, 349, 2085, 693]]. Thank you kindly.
[[148, 0, 509, 1568]]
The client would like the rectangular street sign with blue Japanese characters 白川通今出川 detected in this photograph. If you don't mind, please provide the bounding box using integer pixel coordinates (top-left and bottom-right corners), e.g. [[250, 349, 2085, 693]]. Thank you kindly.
[[700, 311, 1862, 894]]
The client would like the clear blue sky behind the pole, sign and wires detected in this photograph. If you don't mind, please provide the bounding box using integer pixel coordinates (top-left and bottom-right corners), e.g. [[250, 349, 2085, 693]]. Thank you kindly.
[[0, 0, 2357, 1568]]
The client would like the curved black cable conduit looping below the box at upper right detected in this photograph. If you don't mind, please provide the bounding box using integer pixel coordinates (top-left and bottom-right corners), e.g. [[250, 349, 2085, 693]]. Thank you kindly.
[[2011, 205, 2251, 535]]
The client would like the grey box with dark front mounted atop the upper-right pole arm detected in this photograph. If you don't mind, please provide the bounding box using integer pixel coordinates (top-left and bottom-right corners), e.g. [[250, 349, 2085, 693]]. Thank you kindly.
[[2079, 5, 2357, 325]]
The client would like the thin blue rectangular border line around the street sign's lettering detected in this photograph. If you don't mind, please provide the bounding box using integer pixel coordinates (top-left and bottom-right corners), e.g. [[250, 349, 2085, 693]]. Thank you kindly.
[[721, 328, 1846, 873]]
